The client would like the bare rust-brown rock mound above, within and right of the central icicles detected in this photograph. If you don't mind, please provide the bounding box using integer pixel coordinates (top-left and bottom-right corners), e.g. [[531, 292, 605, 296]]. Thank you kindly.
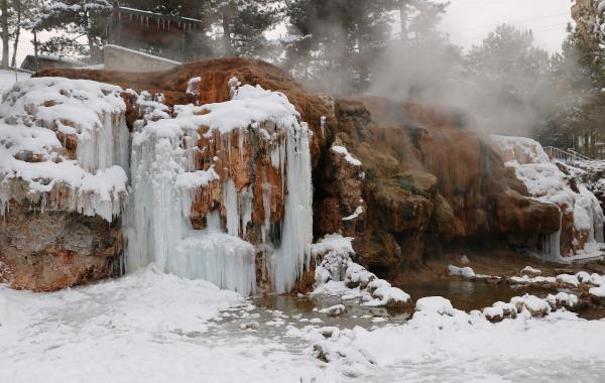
[[37, 58, 565, 285]]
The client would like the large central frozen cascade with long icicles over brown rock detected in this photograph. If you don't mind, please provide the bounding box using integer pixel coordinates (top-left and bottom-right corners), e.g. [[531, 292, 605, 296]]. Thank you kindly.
[[126, 81, 312, 295]]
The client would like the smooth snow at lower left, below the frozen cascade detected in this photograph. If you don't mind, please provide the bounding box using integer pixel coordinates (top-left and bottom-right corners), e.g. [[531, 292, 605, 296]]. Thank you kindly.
[[0, 269, 336, 383]]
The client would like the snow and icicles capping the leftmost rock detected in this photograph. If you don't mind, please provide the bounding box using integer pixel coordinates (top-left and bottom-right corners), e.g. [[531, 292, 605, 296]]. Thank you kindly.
[[0, 78, 129, 222]]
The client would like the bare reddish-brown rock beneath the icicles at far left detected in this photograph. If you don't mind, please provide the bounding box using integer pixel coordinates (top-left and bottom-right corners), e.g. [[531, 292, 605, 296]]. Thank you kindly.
[[0, 203, 124, 291]]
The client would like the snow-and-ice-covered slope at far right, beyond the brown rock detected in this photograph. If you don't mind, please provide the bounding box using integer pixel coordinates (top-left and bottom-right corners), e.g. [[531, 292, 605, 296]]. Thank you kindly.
[[492, 136, 605, 261]]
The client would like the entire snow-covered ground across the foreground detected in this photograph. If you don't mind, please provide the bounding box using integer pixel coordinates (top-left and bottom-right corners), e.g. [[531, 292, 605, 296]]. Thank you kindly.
[[0, 269, 605, 383]]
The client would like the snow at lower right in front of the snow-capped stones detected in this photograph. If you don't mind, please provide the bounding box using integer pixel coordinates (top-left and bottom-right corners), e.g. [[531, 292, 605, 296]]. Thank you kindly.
[[309, 311, 605, 382]]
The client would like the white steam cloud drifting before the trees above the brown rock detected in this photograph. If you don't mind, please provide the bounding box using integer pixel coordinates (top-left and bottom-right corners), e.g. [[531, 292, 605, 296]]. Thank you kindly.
[[368, 25, 581, 136]]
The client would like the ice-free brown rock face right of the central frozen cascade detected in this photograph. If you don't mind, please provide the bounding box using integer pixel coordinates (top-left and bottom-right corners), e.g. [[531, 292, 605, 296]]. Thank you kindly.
[[315, 98, 559, 276]]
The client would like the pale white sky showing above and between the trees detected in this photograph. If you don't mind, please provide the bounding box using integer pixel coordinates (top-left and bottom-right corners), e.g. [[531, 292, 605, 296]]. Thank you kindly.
[[3, 0, 572, 67]]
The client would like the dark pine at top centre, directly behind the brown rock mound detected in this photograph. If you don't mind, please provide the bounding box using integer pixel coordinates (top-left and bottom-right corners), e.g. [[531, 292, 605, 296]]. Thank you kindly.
[[286, 0, 391, 90]]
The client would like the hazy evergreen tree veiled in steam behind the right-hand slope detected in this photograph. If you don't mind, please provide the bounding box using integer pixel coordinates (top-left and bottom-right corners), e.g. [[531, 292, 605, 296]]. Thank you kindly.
[[467, 25, 557, 135]]
